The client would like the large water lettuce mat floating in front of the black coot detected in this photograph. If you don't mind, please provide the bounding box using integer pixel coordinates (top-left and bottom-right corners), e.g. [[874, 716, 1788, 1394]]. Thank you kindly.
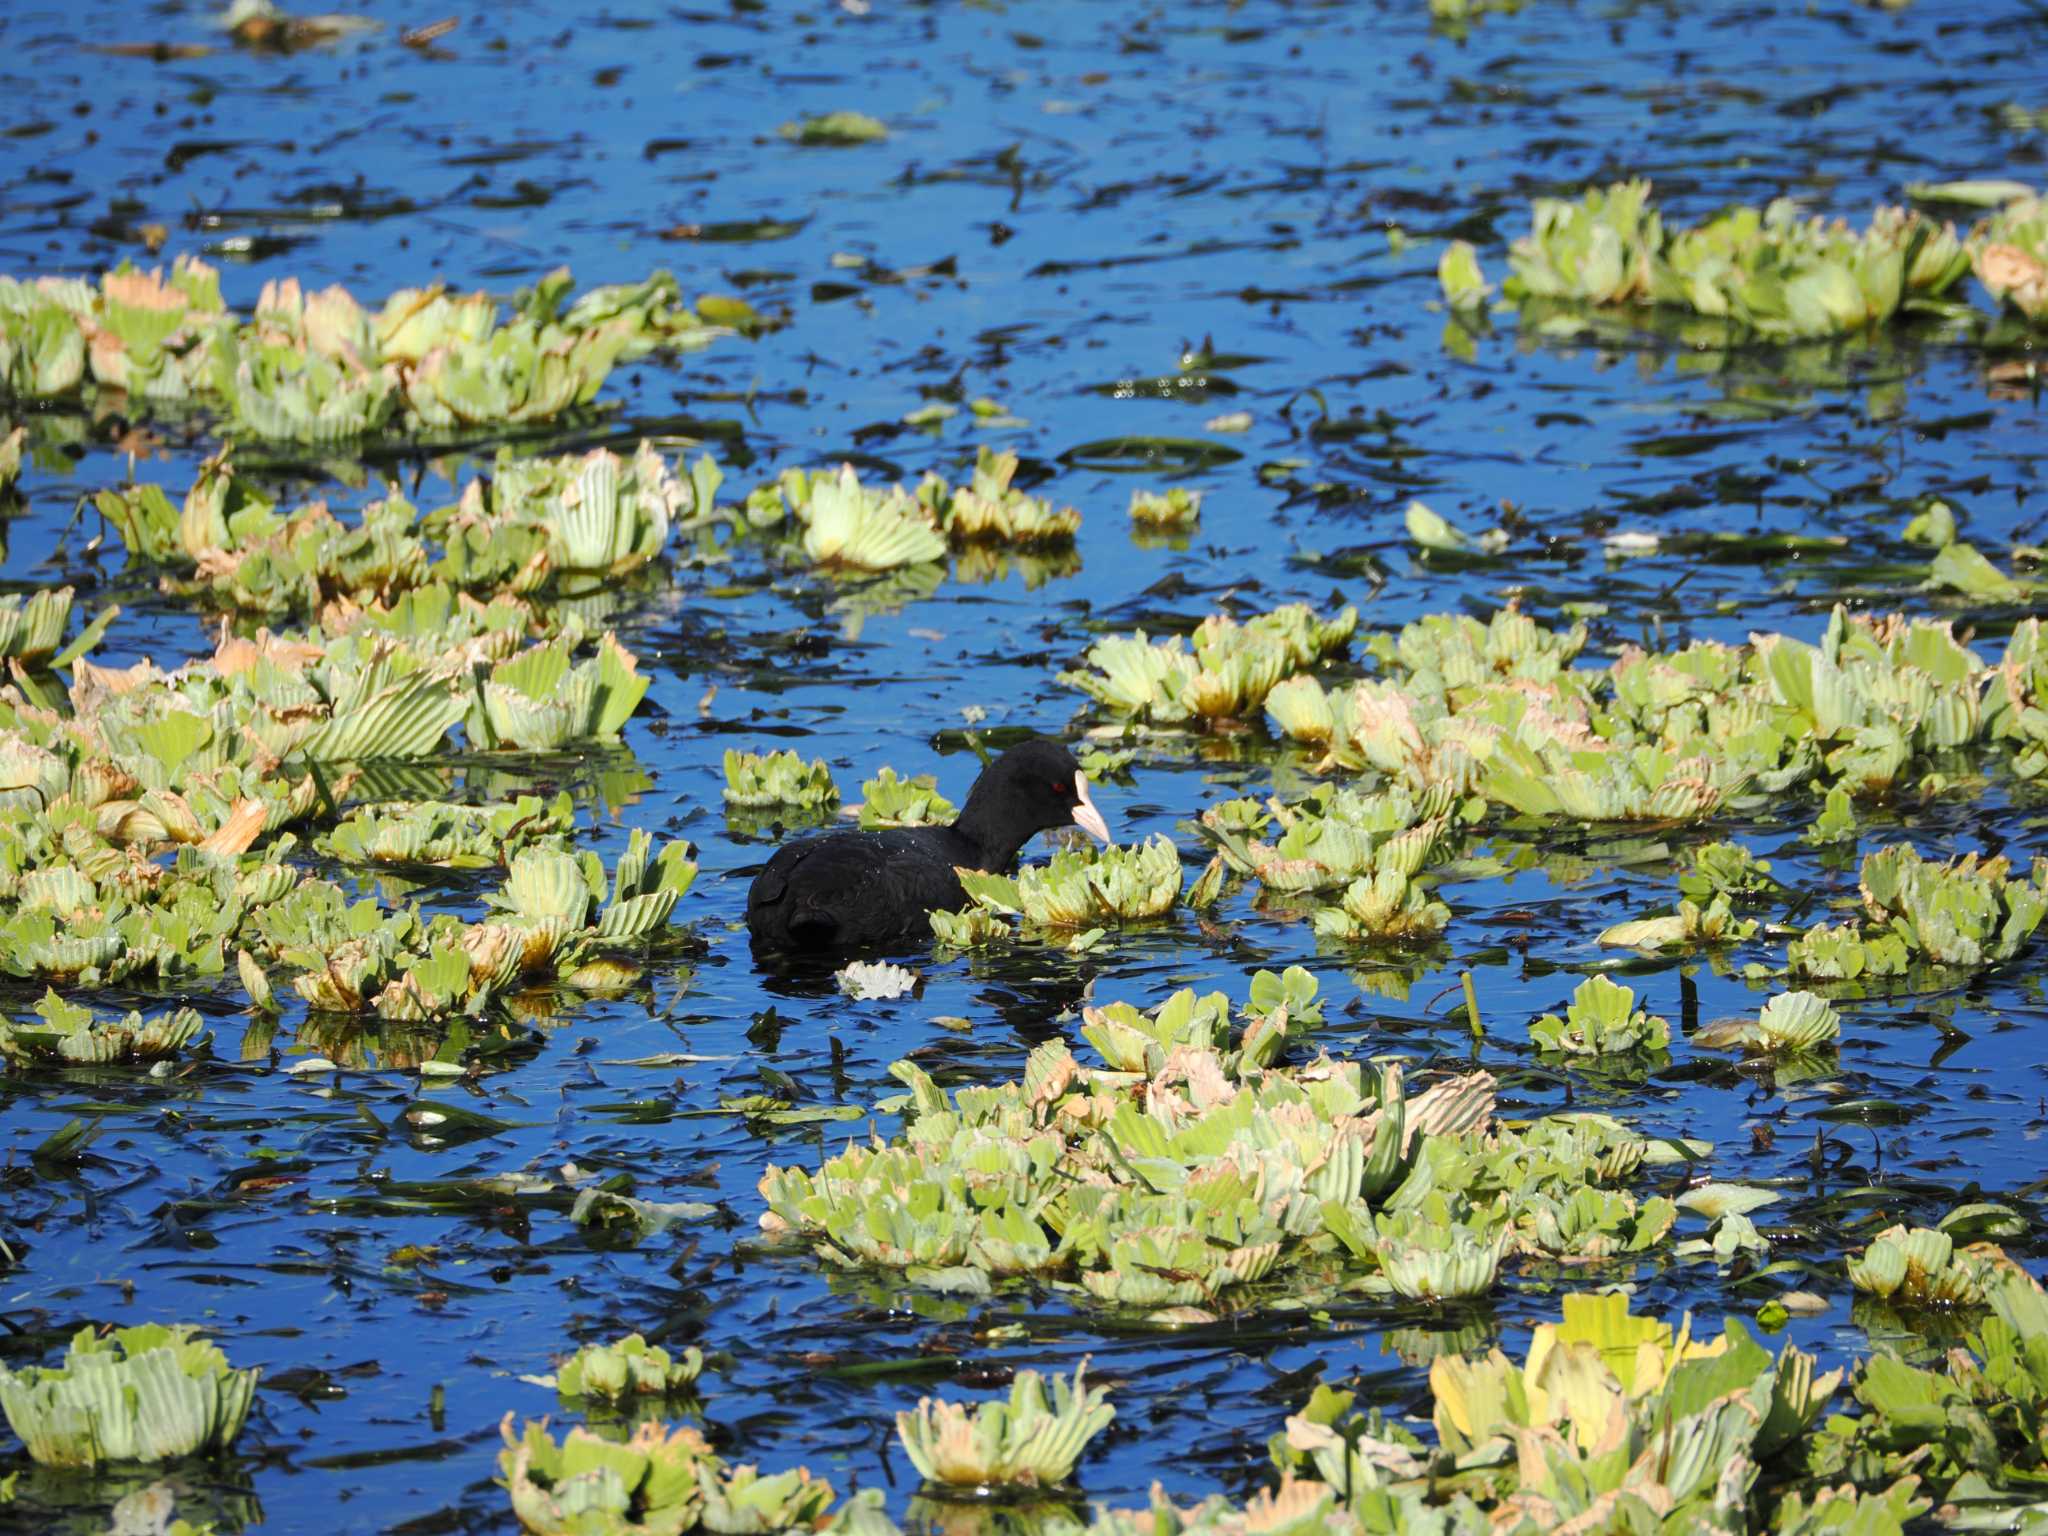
[[760, 971, 1704, 1327]]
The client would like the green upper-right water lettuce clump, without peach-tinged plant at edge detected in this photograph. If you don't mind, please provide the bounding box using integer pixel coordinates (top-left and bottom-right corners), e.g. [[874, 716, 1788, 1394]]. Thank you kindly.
[[1505, 180, 1970, 340]]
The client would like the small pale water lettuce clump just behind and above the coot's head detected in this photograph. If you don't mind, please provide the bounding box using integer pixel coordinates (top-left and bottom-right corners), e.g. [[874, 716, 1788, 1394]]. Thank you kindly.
[[1059, 604, 1358, 725]]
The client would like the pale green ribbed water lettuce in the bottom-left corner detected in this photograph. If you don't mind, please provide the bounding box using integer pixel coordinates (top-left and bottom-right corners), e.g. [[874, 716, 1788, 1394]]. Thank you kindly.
[[0, 1323, 260, 1468]]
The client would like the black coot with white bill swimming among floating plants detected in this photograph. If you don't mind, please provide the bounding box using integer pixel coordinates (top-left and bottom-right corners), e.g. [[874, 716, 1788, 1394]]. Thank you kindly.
[[748, 737, 1110, 954]]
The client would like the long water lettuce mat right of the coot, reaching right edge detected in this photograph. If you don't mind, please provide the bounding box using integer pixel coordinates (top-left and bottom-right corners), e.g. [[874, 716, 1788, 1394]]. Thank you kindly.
[[1266, 606, 2048, 821]]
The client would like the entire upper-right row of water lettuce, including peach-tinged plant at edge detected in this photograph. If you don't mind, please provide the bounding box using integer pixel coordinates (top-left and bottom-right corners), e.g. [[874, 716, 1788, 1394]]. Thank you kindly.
[[1438, 180, 2048, 340]]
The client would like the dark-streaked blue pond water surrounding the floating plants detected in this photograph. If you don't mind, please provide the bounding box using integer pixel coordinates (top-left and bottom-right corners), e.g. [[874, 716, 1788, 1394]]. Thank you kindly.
[[0, 0, 2048, 1532]]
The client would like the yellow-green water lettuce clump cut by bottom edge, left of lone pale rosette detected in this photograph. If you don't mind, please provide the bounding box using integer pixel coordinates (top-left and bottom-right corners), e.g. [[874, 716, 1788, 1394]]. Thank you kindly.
[[498, 1413, 831, 1536]]
